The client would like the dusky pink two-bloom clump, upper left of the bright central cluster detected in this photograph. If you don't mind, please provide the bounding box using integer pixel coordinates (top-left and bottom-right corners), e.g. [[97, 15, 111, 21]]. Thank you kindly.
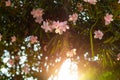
[[31, 8, 43, 24]]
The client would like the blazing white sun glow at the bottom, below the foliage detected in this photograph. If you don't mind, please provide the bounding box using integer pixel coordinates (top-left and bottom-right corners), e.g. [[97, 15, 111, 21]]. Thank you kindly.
[[48, 58, 78, 80]]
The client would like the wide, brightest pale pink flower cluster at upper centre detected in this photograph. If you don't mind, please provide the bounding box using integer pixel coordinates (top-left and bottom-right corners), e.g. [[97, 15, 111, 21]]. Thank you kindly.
[[41, 21, 69, 34]]
